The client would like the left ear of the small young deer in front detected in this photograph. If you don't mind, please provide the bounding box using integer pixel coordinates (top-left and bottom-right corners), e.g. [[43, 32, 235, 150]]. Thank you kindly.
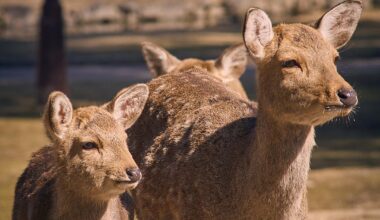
[[43, 92, 73, 139]]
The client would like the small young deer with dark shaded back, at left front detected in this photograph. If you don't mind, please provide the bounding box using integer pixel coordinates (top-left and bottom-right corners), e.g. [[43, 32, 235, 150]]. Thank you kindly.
[[13, 84, 149, 220]]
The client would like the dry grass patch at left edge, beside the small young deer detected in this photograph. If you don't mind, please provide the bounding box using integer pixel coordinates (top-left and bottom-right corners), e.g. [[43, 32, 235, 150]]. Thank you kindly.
[[0, 118, 47, 219]]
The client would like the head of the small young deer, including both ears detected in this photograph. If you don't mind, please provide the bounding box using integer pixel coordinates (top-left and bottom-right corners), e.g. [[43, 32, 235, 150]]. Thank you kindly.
[[44, 84, 149, 199]]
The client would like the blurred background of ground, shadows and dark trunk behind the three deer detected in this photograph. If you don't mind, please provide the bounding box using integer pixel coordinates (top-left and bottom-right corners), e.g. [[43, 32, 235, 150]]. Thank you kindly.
[[0, 0, 380, 219]]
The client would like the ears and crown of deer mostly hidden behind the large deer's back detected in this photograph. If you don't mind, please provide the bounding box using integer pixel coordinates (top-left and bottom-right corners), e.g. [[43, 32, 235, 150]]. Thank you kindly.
[[142, 42, 248, 99]]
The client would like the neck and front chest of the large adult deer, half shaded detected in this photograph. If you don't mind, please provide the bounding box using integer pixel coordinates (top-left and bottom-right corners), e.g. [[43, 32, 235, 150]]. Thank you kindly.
[[240, 105, 315, 219]]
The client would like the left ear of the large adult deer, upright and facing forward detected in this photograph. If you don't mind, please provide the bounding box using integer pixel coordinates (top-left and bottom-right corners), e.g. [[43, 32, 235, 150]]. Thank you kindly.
[[243, 8, 273, 60]]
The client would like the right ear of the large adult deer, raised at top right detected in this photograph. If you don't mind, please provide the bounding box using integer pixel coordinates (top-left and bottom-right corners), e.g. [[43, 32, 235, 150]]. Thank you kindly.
[[315, 0, 362, 49]]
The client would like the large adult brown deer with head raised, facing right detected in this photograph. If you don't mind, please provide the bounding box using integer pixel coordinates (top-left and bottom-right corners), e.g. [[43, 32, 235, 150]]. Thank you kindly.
[[127, 0, 362, 220]]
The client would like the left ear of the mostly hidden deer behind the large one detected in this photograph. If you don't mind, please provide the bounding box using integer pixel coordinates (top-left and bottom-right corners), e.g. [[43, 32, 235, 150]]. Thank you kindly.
[[141, 42, 180, 77]]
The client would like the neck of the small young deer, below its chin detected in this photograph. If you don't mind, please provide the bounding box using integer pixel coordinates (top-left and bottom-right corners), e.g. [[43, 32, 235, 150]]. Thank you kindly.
[[51, 177, 122, 220]]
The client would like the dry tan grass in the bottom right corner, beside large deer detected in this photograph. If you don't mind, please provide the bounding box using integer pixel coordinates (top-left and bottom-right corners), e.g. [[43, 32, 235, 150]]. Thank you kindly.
[[308, 167, 380, 220]]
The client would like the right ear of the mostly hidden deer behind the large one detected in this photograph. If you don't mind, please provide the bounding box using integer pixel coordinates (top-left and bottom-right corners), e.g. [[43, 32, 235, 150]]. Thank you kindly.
[[215, 44, 248, 79]]
